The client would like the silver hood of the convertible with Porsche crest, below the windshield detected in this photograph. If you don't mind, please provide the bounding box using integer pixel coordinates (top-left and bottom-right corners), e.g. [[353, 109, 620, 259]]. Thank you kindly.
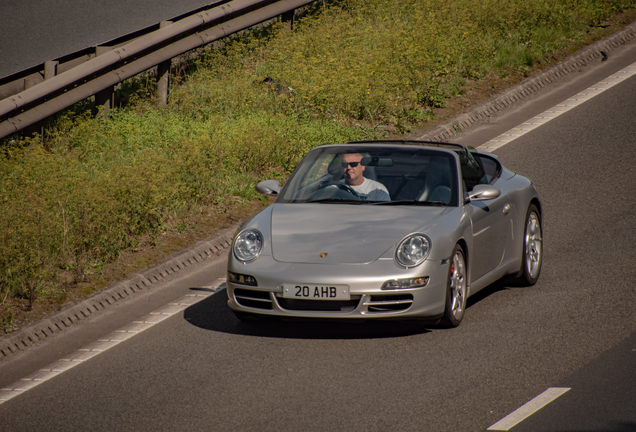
[[271, 204, 446, 264]]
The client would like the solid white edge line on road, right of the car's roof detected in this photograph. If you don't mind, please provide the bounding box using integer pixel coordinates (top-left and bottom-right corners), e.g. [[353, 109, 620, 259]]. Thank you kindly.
[[477, 63, 636, 152]]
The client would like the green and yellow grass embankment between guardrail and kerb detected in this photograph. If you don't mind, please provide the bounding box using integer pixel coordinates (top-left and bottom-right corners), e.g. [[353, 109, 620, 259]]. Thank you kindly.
[[0, 0, 634, 332]]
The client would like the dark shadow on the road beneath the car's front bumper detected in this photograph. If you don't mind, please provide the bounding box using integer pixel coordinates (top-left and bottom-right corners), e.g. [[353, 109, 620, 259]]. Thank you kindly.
[[183, 289, 431, 339]]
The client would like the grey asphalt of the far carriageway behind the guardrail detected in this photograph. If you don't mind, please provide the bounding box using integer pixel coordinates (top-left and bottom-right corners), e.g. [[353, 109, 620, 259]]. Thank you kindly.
[[0, 0, 221, 77]]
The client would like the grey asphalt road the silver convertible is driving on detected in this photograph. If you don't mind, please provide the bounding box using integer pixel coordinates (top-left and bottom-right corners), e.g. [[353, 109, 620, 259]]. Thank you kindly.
[[0, 27, 636, 432]]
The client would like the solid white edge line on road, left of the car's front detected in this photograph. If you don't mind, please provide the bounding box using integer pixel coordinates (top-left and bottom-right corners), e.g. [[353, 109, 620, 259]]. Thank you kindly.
[[0, 278, 225, 404]]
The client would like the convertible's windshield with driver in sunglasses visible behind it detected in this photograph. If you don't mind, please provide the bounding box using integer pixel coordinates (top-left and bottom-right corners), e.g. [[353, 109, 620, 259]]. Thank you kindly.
[[278, 145, 459, 206]]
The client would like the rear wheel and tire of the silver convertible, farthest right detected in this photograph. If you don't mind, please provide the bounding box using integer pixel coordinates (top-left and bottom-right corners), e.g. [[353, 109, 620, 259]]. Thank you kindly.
[[518, 204, 543, 286]]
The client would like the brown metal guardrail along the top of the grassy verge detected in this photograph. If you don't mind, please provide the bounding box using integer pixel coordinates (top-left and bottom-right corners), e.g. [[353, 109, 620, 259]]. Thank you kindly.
[[0, 0, 315, 138]]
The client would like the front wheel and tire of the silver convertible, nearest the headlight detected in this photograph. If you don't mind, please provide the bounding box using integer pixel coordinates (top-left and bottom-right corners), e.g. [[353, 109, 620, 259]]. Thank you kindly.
[[441, 245, 468, 328]]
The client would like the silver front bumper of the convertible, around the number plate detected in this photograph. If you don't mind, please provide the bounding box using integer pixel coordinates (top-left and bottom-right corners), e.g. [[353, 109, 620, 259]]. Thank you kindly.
[[227, 257, 449, 320]]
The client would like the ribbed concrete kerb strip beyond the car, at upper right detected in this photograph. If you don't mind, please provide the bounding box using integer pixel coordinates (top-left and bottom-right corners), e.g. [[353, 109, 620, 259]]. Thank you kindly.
[[417, 22, 636, 142]]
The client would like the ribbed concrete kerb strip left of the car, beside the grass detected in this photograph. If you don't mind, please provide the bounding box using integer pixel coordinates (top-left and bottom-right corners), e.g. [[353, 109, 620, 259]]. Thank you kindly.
[[0, 225, 237, 357]]
